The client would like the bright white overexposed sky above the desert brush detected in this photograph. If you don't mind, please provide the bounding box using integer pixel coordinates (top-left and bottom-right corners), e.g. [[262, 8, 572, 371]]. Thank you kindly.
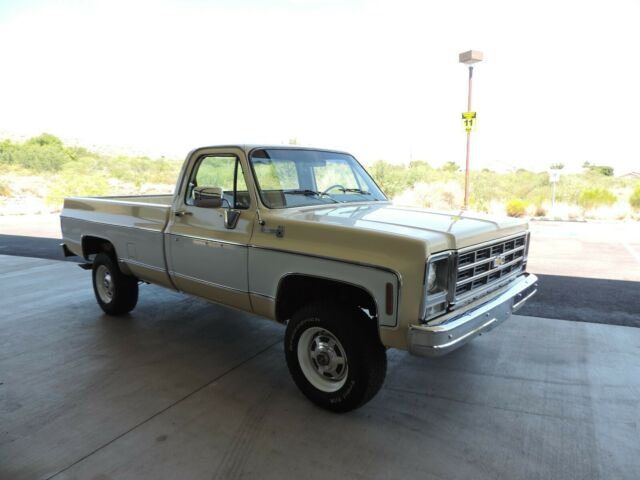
[[0, 0, 640, 173]]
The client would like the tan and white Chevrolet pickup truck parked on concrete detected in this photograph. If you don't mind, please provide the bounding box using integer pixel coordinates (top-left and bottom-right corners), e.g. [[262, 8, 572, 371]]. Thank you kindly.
[[61, 145, 537, 412]]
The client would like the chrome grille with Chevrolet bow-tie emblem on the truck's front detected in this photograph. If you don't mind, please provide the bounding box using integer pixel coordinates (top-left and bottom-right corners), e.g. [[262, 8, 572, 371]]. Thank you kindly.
[[455, 234, 527, 299]]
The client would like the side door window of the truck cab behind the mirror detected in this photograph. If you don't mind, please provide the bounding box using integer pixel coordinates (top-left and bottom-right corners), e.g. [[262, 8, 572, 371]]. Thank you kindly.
[[185, 155, 251, 209]]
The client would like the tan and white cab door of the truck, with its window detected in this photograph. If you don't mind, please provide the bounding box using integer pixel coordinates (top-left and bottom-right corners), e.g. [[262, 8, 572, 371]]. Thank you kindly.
[[166, 150, 255, 310]]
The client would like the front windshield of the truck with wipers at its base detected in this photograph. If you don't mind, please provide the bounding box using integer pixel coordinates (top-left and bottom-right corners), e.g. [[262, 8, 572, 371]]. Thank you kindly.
[[250, 148, 387, 208]]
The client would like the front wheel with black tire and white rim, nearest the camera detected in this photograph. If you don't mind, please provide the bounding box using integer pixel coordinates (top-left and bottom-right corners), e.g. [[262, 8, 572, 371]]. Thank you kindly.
[[285, 303, 387, 412]]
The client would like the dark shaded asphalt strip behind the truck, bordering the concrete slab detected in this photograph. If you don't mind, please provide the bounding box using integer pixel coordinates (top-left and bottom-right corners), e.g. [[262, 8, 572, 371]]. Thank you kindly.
[[0, 235, 640, 327]]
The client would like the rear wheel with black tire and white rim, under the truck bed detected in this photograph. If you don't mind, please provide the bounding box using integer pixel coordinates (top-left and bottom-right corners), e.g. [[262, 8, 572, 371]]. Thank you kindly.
[[92, 253, 138, 315]]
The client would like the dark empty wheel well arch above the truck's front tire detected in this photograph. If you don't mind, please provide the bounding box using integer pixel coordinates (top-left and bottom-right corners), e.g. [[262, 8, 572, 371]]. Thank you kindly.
[[276, 274, 378, 323]]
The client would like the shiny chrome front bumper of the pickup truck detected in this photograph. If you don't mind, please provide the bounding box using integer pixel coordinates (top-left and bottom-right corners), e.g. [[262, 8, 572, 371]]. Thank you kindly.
[[409, 273, 538, 357]]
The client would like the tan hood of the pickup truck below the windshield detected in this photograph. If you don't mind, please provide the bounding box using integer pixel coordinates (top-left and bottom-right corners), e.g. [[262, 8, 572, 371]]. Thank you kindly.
[[279, 203, 527, 253]]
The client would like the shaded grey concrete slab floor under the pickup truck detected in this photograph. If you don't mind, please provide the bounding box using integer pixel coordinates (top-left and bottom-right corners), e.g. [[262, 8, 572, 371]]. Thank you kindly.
[[0, 256, 640, 480]]
